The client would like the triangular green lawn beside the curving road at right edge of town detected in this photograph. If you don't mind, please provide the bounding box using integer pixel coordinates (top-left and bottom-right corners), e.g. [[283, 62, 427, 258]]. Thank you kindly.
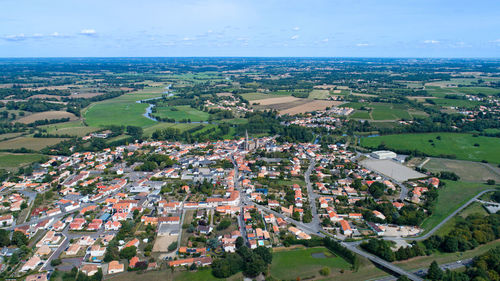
[[421, 180, 492, 233]]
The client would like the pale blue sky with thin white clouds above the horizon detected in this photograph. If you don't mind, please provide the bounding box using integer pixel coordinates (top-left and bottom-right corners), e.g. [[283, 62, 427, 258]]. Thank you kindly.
[[0, 0, 500, 57]]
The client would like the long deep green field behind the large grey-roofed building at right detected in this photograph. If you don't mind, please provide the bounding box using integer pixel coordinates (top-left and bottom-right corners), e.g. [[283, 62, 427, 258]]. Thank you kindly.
[[361, 133, 500, 163]]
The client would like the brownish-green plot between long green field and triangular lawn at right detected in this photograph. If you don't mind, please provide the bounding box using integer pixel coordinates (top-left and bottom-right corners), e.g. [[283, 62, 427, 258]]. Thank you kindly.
[[423, 158, 500, 183]]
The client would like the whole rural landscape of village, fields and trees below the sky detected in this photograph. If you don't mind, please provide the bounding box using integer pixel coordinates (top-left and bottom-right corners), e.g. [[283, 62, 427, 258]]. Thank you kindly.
[[0, 58, 500, 280]]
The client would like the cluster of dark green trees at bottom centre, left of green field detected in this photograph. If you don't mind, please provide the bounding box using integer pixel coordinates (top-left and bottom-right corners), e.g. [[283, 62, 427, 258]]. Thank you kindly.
[[212, 244, 273, 278]]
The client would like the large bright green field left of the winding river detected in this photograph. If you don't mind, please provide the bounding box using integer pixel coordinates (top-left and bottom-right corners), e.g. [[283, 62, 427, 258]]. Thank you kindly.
[[83, 87, 163, 127]]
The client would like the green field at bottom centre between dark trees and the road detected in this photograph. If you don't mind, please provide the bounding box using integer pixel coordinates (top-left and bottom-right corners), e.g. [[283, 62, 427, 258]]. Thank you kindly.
[[270, 247, 351, 280]]
